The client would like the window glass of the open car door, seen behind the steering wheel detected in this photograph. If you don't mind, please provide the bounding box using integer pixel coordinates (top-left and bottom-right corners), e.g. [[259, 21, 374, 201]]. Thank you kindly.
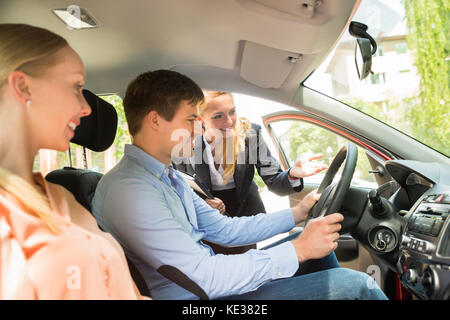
[[270, 120, 377, 188]]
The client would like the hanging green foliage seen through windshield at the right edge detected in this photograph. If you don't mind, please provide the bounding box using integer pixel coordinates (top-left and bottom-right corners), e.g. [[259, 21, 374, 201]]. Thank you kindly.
[[403, 0, 450, 156]]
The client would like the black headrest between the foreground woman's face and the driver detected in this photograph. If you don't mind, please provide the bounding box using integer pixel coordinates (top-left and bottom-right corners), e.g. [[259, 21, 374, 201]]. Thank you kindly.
[[71, 89, 117, 152]]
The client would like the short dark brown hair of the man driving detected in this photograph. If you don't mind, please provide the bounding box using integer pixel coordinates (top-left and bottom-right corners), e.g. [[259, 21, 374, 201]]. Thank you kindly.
[[123, 70, 205, 136]]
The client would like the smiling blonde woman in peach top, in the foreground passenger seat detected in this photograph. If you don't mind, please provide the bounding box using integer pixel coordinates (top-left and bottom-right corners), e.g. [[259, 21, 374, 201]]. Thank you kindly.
[[0, 24, 146, 299]]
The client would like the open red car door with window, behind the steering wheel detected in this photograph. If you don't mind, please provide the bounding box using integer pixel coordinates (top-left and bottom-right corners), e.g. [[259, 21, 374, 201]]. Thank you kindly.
[[262, 110, 395, 292]]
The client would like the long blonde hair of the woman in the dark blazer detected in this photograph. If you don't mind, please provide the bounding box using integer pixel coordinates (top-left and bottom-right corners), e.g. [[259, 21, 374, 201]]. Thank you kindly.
[[199, 90, 252, 185]]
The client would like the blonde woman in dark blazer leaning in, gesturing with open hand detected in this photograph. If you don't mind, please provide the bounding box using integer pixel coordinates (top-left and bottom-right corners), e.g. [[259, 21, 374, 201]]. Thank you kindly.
[[174, 91, 327, 254]]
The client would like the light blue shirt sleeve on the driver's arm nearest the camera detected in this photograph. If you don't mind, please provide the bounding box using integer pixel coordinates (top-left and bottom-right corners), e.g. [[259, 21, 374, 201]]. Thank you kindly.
[[102, 179, 298, 299]]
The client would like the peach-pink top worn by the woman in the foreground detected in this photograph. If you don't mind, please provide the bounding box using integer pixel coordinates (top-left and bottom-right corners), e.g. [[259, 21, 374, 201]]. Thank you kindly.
[[0, 173, 142, 299]]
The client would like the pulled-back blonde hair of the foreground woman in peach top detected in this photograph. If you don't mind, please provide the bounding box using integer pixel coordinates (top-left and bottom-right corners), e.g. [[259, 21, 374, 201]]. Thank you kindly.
[[0, 24, 68, 233]]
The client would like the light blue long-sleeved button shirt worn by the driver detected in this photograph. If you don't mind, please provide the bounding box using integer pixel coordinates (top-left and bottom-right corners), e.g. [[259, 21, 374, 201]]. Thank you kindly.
[[92, 145, 298, 299]]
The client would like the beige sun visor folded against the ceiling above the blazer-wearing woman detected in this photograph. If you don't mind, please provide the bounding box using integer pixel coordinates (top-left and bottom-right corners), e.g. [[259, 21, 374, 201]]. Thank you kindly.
[[240, 41, 303, 88]]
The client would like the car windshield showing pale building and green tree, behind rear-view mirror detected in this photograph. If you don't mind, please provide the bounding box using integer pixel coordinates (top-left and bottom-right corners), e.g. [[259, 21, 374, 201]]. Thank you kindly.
[[304, 0, 450, 156]]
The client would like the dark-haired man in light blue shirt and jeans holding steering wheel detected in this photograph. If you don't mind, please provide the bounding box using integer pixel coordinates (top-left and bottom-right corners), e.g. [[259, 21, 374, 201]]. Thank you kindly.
[[92, 70, 386, 299]]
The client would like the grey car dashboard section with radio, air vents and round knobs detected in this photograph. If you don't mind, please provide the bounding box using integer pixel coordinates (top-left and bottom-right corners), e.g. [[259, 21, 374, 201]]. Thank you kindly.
[[386, 160, 450, 299]]
